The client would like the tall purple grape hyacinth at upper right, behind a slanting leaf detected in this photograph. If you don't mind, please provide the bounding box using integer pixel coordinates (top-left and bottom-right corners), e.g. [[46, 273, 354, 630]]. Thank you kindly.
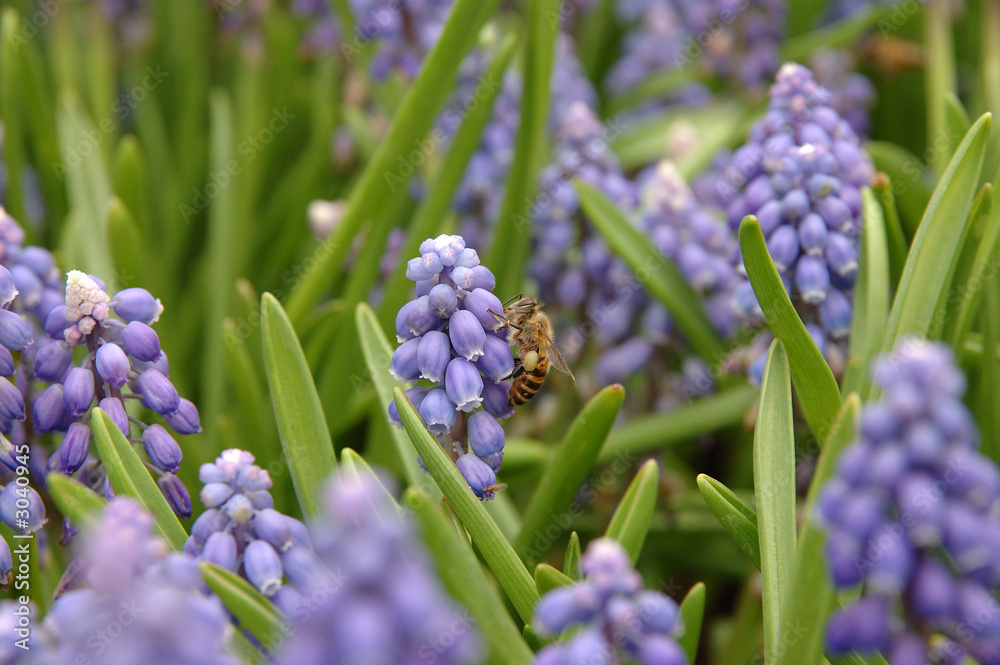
[[715, 63, 874, 378]]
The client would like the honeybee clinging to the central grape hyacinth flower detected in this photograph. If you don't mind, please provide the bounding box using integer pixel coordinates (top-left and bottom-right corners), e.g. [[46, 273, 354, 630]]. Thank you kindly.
[[489, 294, 576, 406]]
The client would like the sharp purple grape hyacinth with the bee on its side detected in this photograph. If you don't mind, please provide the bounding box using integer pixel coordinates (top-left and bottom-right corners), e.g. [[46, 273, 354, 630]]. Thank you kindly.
[[389, 235, 514, 500]]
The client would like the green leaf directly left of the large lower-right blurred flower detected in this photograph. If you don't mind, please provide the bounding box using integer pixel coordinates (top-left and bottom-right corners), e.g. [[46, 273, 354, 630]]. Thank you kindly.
[[776, 393, 861, 665]]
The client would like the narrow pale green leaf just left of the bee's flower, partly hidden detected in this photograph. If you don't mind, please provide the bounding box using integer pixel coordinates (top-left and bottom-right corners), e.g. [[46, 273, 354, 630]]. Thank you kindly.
[[354, 303, 437, 496]]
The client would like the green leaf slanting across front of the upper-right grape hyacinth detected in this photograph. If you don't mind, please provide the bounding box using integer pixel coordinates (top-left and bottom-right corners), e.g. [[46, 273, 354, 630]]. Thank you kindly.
[[740, 215, 840, 439]]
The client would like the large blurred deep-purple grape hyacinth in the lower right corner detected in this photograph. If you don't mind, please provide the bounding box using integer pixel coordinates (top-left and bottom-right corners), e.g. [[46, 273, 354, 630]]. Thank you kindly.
[[818, 339, 1000, 665]]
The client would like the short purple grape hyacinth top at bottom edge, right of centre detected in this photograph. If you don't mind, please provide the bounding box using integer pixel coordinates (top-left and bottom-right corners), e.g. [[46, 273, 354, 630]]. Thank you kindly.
[[532, 538, 687, 665]]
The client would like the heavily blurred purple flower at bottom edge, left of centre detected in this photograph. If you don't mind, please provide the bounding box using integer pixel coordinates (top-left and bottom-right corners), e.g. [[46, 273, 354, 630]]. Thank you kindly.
[[275, 473, 484, 665]]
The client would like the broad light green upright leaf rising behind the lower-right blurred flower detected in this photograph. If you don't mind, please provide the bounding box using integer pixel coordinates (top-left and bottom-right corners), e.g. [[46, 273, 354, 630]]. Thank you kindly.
[[882, 114, 990, 351]]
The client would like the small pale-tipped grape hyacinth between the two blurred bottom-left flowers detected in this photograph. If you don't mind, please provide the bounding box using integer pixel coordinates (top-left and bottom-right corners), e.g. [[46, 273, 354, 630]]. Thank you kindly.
[[184, 448, 315, 597]]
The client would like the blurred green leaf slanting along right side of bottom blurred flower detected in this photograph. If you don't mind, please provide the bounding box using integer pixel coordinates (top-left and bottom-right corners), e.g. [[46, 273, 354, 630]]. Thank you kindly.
[[403, 487, 534, 665]]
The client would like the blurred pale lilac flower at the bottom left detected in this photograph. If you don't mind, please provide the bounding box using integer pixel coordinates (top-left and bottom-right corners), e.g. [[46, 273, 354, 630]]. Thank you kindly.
[[31, 497, 239, 665]]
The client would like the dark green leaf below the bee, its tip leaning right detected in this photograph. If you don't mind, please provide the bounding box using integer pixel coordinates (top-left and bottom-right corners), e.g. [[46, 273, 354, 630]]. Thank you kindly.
[[514, 384, 625, 566]]
